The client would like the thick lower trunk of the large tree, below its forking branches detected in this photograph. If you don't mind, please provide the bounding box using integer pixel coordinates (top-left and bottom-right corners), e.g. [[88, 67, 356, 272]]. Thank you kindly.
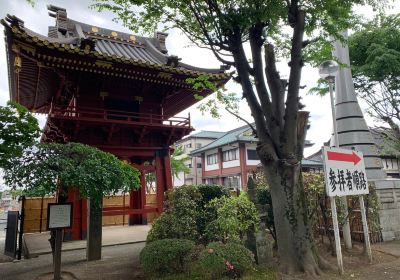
[[264, 161, 321, 275]]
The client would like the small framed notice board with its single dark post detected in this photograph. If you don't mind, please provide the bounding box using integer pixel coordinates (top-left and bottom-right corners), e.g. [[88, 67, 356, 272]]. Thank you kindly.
[[47, 203, 72, 280]]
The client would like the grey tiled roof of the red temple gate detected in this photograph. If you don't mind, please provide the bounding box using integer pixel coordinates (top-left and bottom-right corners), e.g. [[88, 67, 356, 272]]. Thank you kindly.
[[1, 5, 229, 76]]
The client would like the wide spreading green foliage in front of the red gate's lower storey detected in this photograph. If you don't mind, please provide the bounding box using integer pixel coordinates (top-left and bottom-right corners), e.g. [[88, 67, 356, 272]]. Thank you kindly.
[[4, 143, 140, 205]]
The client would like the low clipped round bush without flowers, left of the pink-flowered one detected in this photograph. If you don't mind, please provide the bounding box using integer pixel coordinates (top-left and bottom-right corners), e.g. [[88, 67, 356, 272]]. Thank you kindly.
[[139, 239, 196, 276]]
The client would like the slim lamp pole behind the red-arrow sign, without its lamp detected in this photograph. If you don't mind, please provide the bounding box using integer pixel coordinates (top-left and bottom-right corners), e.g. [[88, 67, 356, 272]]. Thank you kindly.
[[328, 79, 352, 250]]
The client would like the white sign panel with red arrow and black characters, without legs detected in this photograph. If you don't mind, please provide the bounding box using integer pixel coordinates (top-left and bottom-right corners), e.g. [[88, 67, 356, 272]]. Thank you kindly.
[[322, 147, 369, 196]]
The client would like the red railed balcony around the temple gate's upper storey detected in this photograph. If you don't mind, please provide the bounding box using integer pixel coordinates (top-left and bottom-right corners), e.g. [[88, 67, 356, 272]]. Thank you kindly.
[[49, 107, 191, 129]]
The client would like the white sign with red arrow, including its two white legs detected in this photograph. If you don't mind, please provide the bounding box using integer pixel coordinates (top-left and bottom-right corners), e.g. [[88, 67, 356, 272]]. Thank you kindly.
[[323, 147, 372, 273]]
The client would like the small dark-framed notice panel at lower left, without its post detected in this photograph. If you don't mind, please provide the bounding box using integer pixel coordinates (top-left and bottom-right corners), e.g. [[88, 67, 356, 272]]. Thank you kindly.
[[47, 203, 72, 230]]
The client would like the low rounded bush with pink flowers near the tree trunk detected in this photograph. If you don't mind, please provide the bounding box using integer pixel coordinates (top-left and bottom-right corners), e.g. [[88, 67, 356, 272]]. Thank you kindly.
[[199, 242, 254, 279]]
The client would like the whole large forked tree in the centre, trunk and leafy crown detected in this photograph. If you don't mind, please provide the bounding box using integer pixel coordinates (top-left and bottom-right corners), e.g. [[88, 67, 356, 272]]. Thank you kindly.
[[94, 0, 386, 275]]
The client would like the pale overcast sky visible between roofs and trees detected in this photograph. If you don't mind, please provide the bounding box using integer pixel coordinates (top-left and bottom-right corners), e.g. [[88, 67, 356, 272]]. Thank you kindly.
[[0, 0, 400, 163]]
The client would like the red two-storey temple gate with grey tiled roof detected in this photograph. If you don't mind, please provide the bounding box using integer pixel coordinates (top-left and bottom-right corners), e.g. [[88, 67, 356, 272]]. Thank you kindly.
[[1, 5, 229, 239]]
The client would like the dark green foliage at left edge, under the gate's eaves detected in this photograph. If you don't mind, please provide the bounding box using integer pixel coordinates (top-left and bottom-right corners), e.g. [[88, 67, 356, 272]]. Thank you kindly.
[[0, 102, 40, 168]]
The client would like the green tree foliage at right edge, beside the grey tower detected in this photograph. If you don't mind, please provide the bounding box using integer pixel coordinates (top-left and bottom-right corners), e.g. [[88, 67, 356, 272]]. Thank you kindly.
[[349, 14, 400, 150]]
